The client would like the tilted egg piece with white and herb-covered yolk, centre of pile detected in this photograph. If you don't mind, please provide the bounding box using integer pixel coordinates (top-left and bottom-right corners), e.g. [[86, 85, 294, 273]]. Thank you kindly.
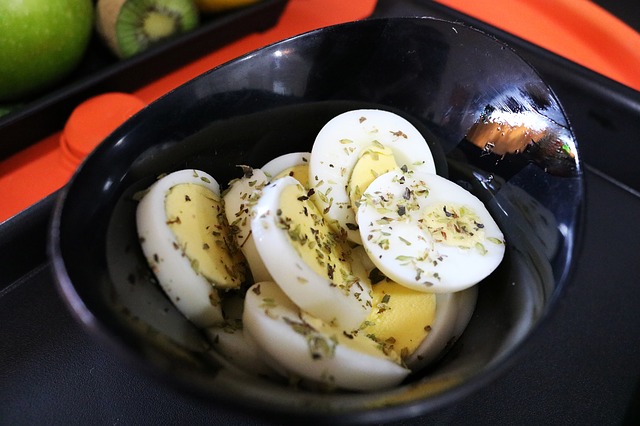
[[251, 176, 371, 330]]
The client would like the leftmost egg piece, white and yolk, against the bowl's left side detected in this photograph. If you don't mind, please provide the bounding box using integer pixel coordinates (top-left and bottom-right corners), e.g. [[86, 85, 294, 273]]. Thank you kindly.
[[136, 170, 244, 327]]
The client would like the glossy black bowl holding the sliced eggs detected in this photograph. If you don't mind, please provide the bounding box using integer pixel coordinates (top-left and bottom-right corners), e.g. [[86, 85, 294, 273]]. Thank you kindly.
[[49, 18, 583, 422]]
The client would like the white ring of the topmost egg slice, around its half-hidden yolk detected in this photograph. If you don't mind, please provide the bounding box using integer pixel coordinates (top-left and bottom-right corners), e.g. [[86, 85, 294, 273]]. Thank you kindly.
[[309, 109, 436, 243]]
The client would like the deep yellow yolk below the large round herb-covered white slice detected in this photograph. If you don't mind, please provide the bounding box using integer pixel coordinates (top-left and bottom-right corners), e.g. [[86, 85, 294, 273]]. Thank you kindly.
[[360, 279, 436, 359]]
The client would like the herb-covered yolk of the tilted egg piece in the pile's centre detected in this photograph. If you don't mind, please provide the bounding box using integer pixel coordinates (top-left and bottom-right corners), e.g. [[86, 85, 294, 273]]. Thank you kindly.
[[277, 185, 358, 293]]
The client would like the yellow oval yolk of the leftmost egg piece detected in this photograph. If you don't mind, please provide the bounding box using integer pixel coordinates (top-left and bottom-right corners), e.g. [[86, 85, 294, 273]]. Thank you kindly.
[[165, 183, 245, 288]]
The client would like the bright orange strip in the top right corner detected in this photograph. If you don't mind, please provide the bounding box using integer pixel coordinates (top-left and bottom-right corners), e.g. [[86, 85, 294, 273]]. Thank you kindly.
[[437, 0, 640, 90]]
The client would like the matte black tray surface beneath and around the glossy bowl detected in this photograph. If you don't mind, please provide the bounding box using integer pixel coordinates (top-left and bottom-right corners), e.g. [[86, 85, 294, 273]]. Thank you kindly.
[[0, 1, 640, 425]]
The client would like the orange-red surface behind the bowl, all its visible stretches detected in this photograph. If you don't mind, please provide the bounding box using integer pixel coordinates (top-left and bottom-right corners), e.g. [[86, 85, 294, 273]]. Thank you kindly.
[[0, 0, 640, 222]]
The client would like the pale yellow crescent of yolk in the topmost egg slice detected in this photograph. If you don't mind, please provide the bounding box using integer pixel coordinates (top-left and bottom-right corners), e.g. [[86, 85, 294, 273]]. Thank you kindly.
[[347, 143, 398, 210]]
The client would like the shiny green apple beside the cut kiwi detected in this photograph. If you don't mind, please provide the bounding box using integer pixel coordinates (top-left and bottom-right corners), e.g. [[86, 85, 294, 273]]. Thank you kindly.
[[0, 0, 93, 102]]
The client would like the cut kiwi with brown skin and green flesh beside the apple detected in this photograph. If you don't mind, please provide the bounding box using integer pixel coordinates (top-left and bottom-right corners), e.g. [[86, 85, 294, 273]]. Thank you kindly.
[[96, 0, 199, 58]]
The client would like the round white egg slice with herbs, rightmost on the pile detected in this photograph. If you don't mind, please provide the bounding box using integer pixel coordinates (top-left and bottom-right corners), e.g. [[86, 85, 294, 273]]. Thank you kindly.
[[358, 170, 505, 293]]
